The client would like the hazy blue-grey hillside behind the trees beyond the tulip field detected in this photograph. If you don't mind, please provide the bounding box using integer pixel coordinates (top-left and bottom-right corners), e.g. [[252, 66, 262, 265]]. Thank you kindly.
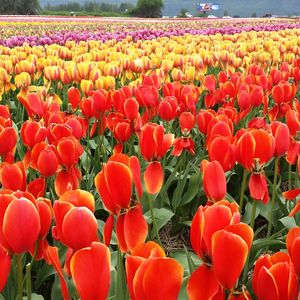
[[40, 0, 300, 17]]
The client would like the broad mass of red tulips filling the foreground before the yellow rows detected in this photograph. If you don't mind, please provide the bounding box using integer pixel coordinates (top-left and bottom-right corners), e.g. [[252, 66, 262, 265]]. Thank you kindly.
[[0, 52, 300, 300]]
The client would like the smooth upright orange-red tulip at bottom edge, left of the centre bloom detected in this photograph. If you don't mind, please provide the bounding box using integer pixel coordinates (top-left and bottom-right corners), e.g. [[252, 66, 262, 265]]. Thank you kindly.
[[70, 242, 110, 300]]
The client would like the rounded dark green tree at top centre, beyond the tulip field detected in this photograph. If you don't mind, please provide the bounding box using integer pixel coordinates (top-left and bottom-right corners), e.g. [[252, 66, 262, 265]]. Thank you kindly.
[[134, 0, 164, 18]]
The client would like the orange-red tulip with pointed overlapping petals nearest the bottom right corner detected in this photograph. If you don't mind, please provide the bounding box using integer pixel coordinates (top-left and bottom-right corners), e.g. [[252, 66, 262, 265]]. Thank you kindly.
[[252, 252, 298, 300]]
